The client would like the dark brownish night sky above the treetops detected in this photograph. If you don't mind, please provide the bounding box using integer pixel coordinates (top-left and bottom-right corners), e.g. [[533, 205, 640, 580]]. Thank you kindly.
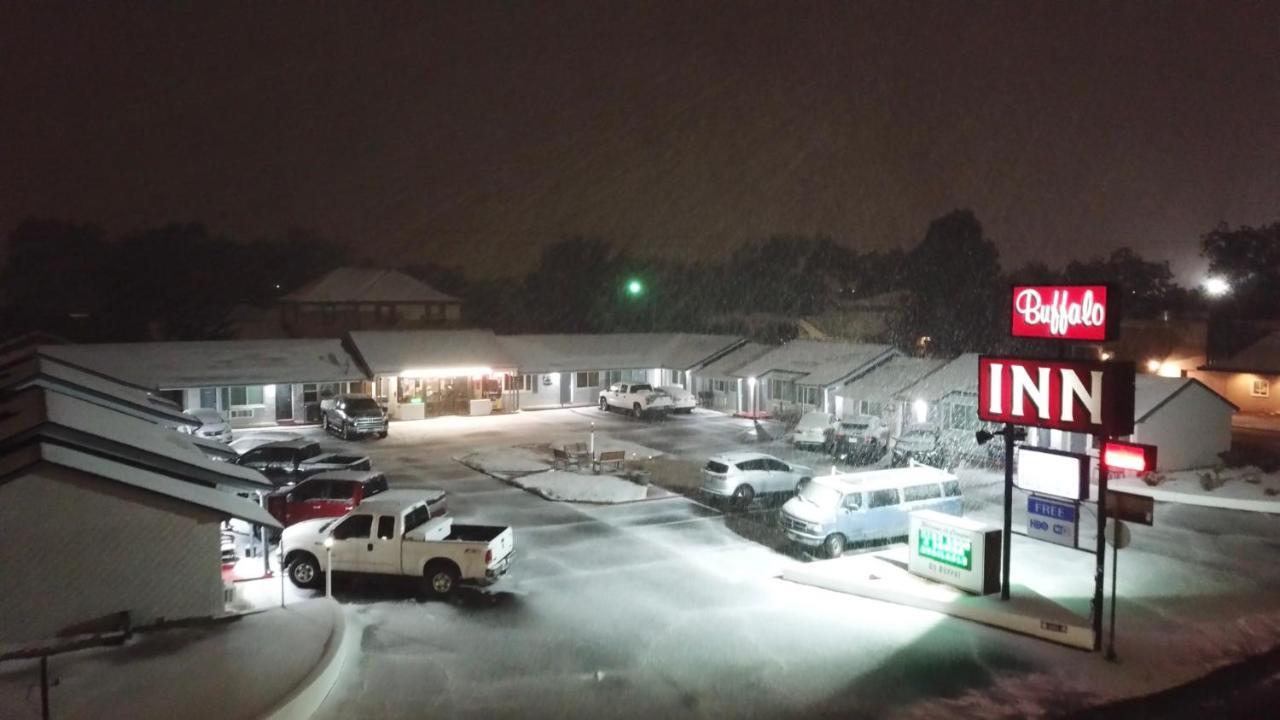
[[0, 1, 1280, 277]]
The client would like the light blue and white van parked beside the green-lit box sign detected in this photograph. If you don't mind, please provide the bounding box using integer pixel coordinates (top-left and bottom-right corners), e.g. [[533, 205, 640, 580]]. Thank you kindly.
[[781, 465, 964, 557]]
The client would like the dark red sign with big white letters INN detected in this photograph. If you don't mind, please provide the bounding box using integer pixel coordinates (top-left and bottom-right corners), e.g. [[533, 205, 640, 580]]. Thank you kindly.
[[978, 356, 1133, 436]]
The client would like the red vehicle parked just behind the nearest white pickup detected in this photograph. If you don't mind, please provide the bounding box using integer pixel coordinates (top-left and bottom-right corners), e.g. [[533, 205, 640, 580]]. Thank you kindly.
[[266, 470, 448, 527]]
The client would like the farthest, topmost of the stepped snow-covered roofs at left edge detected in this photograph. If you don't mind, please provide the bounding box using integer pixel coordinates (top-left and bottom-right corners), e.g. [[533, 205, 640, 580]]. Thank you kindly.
[[0, 352, 200, 427]]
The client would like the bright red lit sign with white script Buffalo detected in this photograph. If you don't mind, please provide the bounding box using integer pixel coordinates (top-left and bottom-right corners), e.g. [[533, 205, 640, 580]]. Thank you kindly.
[[1010, 284, 1115, 342]]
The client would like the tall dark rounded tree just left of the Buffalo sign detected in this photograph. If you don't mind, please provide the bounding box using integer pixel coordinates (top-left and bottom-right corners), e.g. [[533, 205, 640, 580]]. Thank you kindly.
[[895, 210, 1007, 356]]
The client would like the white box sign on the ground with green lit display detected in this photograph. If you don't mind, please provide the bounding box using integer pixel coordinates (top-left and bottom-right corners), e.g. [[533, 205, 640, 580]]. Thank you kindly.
[[906, 510, 1000, 594]]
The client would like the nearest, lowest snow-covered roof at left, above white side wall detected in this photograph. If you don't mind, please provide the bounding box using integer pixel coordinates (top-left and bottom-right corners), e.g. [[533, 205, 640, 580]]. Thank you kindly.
[[0, 442, 280, 527]]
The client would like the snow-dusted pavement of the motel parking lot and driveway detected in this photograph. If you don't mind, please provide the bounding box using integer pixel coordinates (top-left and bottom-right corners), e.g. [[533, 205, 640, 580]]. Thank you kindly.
[[252, 409, 1280, 719]]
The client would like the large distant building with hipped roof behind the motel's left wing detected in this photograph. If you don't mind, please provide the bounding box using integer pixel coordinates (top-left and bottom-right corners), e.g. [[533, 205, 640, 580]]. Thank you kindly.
[[279, 268, 462, 337]]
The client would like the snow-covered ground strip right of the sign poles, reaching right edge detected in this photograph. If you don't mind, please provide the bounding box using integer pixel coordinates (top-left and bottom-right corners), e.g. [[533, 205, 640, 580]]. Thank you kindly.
[[1108, 468, 1280, 514]]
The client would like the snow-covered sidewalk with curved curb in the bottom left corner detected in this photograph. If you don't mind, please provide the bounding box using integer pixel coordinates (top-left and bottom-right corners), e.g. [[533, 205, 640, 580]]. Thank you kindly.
[[0, 600, 353, 720]]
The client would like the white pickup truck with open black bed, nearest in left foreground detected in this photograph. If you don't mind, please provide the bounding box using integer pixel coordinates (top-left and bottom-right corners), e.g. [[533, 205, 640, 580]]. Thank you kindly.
[[280, 491, 516, 597]]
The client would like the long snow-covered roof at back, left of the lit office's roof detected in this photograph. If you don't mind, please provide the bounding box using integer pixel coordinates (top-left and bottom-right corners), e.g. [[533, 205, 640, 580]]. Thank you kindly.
[[41, 338, 365, 389]]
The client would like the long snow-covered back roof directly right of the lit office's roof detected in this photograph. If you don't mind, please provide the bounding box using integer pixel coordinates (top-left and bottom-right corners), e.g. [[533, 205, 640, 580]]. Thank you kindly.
[[498, 333, 742, 373]]
